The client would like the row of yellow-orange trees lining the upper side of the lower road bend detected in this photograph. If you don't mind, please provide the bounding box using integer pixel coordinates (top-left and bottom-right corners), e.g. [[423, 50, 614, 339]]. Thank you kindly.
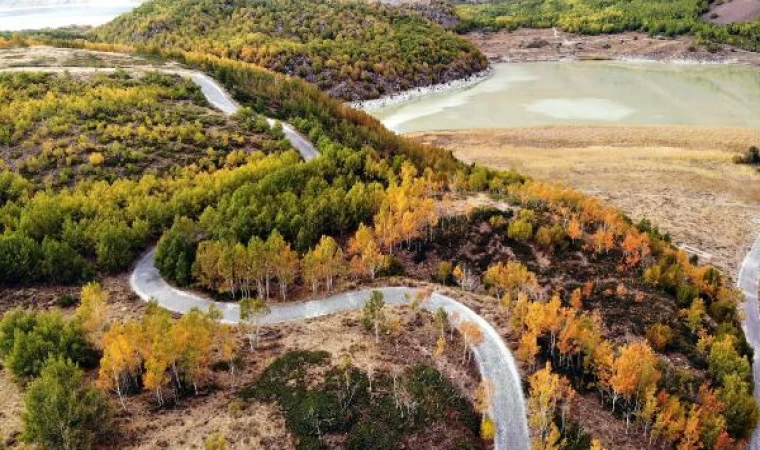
[[156, 163, 438, 300]]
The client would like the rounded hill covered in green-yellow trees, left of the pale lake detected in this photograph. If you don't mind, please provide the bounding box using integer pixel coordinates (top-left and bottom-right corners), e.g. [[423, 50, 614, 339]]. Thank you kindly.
[[91, 0, 487, 100]]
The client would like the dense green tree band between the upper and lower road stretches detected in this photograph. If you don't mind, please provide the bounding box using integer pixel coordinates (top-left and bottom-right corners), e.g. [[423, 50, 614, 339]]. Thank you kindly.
[[0, 54, 510, 284]]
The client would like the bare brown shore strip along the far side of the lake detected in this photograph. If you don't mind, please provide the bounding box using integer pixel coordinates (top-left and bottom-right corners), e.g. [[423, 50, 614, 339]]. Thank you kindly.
[[467, 27, 760, 65]]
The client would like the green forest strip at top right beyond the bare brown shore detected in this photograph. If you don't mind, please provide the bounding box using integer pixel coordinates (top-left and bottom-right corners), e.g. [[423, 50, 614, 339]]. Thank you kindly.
[[457, 0, 760, 51]]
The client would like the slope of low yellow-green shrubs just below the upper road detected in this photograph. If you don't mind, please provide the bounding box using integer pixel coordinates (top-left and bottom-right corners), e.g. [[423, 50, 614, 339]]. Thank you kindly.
[[0, 71, 289, 186]]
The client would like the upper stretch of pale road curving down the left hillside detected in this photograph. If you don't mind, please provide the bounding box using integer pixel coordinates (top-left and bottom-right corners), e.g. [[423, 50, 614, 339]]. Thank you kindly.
[[0, 66, 319, 161]]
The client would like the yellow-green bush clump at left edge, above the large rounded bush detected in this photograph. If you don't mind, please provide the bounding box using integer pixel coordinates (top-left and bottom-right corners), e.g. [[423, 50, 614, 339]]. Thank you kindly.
[[0, 309, 97, 380]]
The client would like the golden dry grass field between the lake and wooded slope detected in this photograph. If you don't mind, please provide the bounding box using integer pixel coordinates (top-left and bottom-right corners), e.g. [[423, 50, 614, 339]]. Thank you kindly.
[[415, 126, 760, 275]]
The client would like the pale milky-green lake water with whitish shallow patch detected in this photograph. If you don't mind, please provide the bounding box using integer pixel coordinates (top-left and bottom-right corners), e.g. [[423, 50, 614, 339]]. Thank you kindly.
[[370, 62, 760, 132]]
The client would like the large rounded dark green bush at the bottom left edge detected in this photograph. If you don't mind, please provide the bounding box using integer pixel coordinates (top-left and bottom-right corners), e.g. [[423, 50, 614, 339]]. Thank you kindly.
[[22, 358, 111, 450]]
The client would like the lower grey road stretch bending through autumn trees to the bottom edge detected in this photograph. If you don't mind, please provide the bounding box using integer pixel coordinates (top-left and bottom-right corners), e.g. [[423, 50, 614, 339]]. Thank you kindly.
[[129, 248, 530, 450]]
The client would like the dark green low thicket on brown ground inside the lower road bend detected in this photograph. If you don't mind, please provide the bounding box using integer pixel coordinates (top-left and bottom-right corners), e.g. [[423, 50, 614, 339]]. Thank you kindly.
[[241, 351, 481, 450]]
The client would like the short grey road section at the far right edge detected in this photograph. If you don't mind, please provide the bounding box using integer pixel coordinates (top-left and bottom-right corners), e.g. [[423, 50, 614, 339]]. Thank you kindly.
[[737, 236, 760, 450]]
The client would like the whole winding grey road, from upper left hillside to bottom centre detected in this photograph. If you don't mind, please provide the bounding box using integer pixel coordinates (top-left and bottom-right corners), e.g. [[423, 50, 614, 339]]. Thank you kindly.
[[5, 59, 530, 450]]
